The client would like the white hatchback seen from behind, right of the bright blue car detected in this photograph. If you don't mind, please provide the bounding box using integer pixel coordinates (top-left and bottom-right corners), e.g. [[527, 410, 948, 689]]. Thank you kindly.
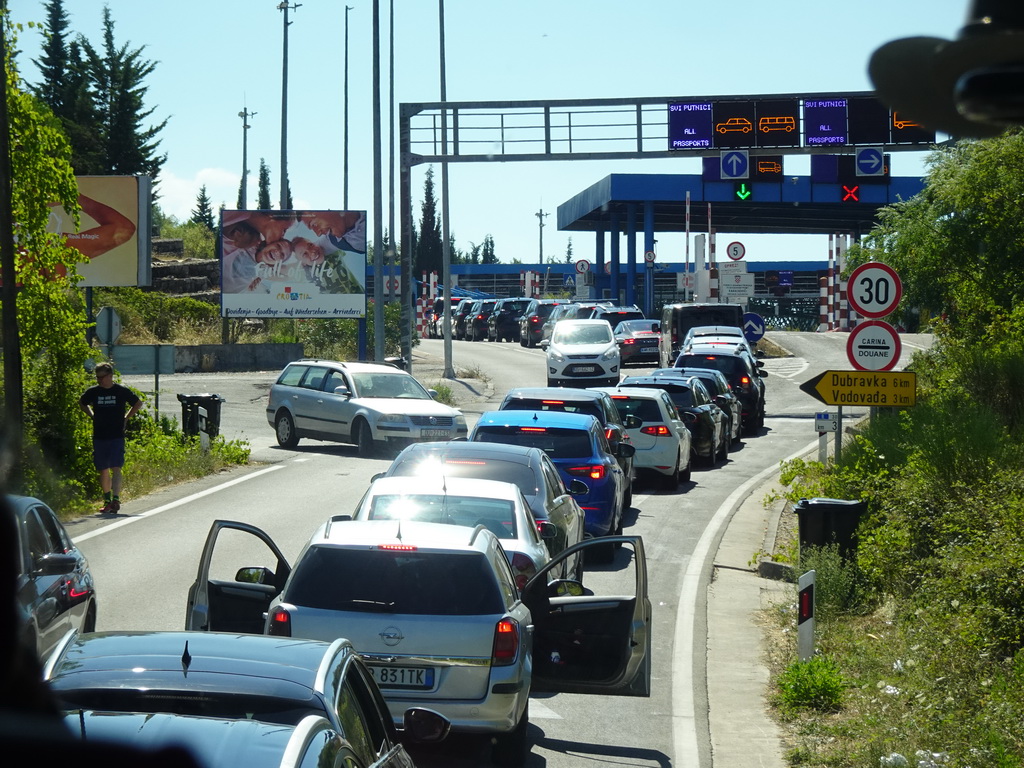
[[598, 387, 693, 490]]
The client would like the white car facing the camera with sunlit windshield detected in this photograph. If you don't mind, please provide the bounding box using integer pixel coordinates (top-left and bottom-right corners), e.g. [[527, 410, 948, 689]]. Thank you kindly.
[[546, 319, 621, 387]]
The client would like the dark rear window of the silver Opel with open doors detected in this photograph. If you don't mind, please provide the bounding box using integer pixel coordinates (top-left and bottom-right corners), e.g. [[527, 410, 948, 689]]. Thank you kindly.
[[283, 548, 505, 615]]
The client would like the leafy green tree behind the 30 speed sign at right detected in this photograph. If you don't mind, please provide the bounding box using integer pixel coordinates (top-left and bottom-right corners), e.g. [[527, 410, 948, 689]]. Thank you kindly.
[[851, 129, 1024, 339]]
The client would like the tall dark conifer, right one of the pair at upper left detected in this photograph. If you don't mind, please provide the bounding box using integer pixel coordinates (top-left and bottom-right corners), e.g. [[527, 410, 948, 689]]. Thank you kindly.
[[79, 6, 167, 178]]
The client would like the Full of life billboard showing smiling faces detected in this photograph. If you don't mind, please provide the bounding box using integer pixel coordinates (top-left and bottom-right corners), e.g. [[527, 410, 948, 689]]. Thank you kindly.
[[220, 211, 367, 318]]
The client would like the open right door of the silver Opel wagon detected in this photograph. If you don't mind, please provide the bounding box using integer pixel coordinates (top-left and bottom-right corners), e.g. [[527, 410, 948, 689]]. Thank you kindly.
[[521, 536, 652, 696]]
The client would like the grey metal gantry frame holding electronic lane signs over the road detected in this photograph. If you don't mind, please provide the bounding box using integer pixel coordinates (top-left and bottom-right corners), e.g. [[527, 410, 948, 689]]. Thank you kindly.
[[398, 91, 928, 370]]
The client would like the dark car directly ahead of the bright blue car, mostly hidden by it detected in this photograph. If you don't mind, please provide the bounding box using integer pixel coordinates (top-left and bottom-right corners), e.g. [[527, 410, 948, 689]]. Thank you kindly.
[[498, 387, 640, 507]]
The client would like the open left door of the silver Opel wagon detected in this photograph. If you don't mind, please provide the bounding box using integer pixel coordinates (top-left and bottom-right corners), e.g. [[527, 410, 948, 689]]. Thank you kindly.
[[185, 520, 292, 635]]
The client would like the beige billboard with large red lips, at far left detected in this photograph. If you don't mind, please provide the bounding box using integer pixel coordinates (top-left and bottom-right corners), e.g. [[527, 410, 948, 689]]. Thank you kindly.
[[46, 176, 153, 287]]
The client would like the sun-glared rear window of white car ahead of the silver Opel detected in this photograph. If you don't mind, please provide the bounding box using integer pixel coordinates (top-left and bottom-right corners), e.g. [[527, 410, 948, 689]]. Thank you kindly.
[[368, 494, 516, 539]]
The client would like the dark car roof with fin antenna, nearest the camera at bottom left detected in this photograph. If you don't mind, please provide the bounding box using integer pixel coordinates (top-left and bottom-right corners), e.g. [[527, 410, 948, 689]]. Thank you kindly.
[[45, 630, 355, 695]]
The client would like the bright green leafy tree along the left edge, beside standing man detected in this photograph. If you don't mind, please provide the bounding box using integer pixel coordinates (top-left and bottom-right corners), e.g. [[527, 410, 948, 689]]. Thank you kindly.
[[0, 17, 93, 502]]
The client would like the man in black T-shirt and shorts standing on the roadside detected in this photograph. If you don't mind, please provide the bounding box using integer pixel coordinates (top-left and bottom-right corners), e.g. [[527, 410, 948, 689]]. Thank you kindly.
[[78, 362, 142, 514]]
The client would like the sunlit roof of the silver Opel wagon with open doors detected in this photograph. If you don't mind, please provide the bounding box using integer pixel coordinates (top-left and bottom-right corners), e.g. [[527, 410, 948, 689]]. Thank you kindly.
[[317, 518, 500, 552]]
